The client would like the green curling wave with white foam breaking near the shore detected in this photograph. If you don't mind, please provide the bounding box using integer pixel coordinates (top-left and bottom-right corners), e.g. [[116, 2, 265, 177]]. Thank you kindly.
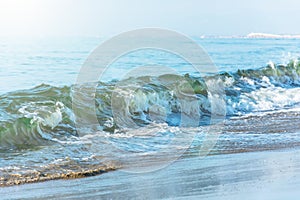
[[0, 60, 300, 150]]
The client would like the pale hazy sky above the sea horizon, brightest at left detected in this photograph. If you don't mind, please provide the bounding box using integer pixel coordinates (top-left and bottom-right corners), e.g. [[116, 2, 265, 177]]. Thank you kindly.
[[0, 0, 300, 36]]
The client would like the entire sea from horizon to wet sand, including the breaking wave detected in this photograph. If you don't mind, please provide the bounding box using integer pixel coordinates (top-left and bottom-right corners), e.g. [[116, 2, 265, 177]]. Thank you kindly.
[[0, 37, 300, 185]]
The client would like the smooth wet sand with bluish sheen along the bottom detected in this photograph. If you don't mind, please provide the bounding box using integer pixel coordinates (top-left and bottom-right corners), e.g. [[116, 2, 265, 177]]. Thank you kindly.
[[0, 149, 300, 200]]
